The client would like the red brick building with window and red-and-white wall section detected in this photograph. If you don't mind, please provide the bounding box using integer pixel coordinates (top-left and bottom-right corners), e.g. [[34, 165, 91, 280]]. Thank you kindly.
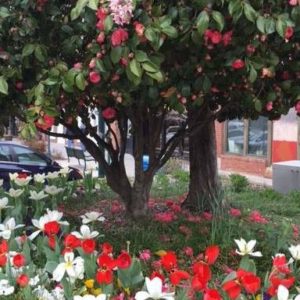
[[216, 109, 300, 177]]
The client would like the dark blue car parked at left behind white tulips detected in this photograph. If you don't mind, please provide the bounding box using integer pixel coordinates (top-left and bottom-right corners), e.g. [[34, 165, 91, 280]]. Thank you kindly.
[[0, 141, 82, 188]]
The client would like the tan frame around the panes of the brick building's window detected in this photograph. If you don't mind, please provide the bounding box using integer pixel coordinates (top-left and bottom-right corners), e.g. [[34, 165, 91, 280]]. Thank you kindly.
[[223, 119, 273, 165]]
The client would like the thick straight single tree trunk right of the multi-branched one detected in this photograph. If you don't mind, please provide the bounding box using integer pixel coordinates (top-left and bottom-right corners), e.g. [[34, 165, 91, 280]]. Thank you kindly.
[[183, 107, 219, 211]]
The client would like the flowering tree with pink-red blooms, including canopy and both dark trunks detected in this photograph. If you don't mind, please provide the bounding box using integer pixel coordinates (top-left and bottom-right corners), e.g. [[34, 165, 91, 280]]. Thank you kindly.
[[0, 0, 300, 216]]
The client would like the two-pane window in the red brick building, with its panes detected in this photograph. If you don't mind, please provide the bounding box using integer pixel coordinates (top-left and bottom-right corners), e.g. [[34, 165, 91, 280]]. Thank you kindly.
[[226, 117, 269, 157]]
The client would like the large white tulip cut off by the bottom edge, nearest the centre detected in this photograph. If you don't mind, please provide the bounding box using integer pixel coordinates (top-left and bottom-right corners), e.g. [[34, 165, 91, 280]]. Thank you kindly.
[[134, 277, 175, 300]]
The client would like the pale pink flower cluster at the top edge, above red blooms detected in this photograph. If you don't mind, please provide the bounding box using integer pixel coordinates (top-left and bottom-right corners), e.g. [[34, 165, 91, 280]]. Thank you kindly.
[[109, 0, 133, 26]]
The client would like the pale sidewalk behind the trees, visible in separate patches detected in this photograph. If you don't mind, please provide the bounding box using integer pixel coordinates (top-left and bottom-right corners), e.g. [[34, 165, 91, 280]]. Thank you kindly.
[[50, 142, 272, 187]]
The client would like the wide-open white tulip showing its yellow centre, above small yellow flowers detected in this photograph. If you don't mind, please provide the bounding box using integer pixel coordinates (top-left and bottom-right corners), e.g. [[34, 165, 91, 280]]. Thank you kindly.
[[53, 252, 84, 282]]
